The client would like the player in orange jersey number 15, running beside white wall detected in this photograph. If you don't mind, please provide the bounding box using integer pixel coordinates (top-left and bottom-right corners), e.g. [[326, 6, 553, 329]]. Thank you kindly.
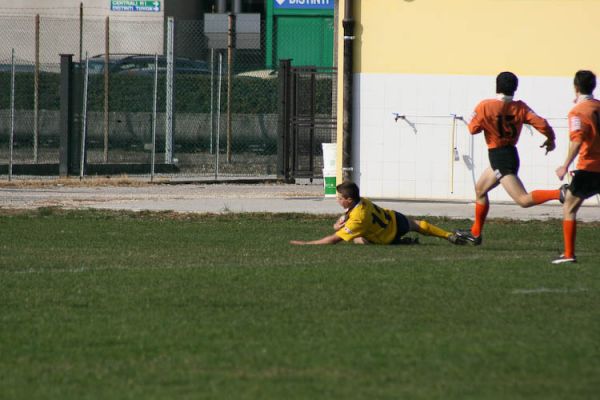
[[456, 72, 564, 246]]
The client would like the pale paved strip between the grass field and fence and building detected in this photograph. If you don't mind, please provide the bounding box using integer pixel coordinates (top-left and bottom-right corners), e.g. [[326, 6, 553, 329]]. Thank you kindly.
[[0, 183, 600, 221]]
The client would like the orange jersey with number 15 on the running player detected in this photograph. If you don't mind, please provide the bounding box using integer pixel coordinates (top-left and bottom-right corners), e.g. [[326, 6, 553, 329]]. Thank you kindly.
[[469, 99, 554, 149]]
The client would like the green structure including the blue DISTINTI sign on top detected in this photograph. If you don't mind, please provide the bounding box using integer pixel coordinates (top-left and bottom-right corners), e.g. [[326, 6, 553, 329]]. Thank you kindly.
[[265, 0, 334, 68]]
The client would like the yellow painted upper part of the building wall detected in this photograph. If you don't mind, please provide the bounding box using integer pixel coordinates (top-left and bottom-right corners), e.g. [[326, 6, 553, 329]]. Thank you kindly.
[[337, 0, 600, 189]]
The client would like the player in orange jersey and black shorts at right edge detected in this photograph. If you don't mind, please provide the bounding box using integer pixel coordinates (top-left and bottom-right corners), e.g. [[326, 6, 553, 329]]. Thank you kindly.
[[552, 71, 600, 264]]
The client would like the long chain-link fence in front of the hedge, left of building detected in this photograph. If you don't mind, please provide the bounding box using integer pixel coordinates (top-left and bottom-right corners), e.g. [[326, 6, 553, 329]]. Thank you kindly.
[[0, 12, 336, 177]]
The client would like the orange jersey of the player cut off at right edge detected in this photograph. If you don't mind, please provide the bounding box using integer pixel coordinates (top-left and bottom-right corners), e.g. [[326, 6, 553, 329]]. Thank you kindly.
[[569, 98, 600, 172]]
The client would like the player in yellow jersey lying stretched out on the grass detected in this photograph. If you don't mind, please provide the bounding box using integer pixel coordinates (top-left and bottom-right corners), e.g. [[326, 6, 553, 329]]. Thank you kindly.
[[290, 181, 465, 244]]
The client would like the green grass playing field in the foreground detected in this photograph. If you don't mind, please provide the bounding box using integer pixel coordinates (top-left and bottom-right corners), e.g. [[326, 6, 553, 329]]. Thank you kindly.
[[0, 209, 600, 400]]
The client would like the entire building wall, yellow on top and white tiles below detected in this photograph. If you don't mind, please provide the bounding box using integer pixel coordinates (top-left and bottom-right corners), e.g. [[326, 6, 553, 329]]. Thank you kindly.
[[337, 0, 600, 206]]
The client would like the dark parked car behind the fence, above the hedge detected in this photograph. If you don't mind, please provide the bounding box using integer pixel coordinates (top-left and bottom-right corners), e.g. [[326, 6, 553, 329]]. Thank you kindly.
[[88, 54, 210, 75]]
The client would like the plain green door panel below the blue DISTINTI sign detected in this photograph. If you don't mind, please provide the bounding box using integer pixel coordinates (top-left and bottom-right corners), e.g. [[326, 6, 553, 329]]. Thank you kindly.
[[275, 16, 333, 67]]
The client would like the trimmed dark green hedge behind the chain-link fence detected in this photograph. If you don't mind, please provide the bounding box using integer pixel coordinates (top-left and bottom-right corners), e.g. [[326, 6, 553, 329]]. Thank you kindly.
[[0, 72, 332, 114]]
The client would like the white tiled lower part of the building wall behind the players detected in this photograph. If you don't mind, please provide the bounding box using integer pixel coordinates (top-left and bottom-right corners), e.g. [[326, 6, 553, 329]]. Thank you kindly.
[[353, 73, 574, 200]]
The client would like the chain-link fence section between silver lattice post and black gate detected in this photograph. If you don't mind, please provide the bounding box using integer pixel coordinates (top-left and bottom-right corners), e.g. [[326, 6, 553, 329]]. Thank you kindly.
[[174, 21, 278, 176]]
